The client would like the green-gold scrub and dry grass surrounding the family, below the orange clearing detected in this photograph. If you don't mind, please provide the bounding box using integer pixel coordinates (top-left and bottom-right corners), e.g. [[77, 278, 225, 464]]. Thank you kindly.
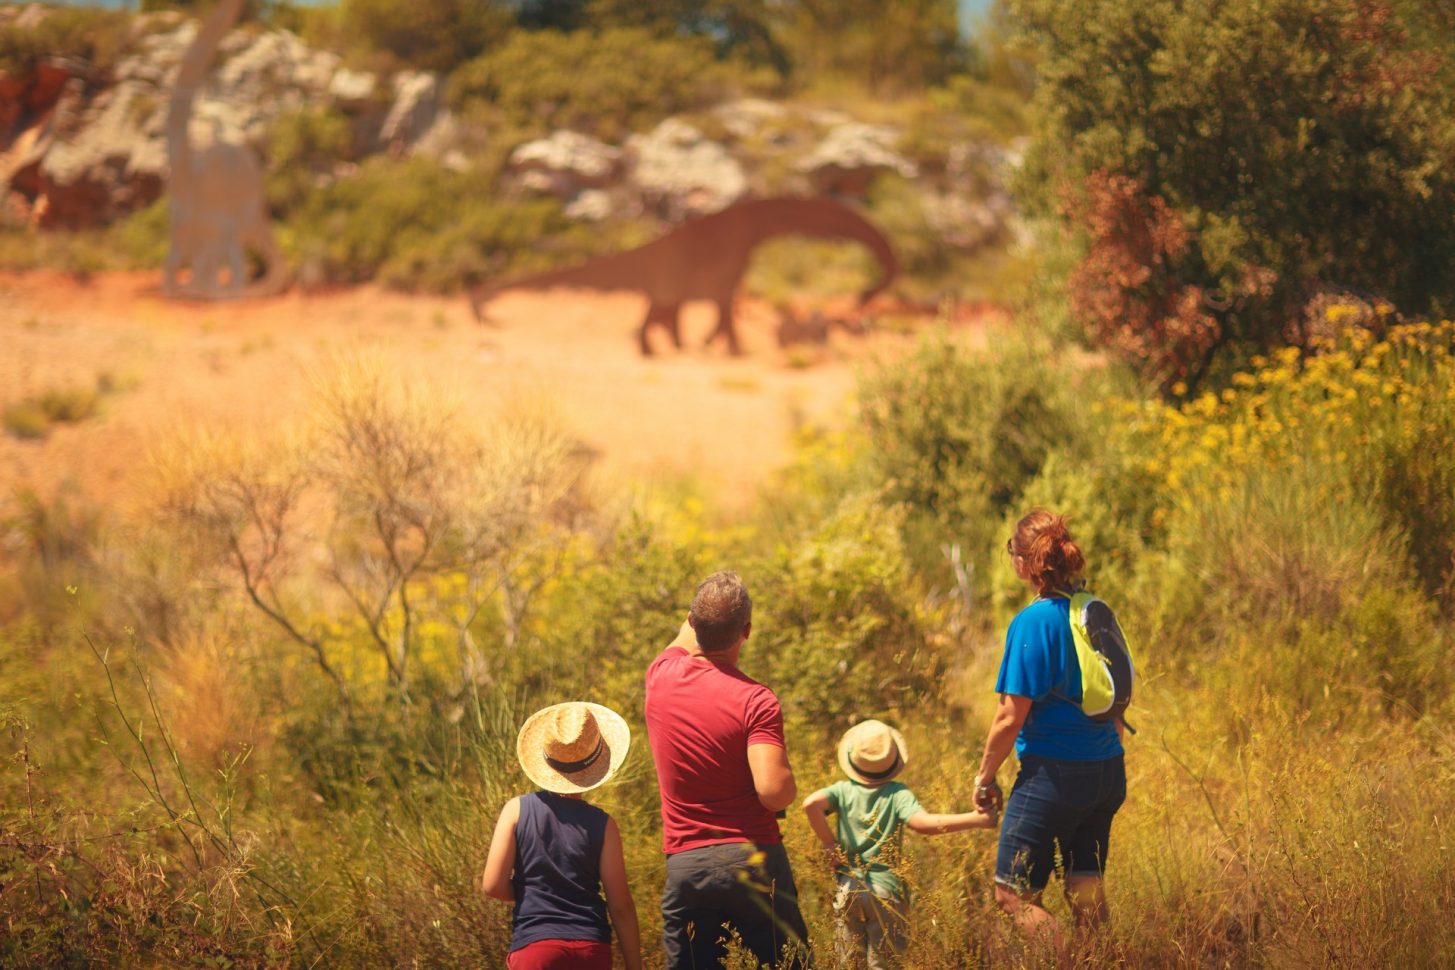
[[0, 315, 1455, 967]]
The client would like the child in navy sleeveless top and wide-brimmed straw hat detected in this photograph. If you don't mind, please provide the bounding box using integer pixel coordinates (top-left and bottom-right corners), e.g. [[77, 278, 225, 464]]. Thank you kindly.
[[480, 702, 642, 970]]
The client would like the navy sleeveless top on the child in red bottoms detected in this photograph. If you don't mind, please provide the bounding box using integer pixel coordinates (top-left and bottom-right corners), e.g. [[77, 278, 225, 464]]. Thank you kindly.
[[511, 791, 611, 951]]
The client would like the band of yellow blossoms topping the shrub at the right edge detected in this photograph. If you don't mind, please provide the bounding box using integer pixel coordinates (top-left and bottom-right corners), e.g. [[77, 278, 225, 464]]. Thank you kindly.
[[1113, 321, 1455, 561]]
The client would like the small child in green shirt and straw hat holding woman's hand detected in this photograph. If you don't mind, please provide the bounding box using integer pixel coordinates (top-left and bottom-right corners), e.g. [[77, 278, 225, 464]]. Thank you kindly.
[[803, 720, 995, 970]]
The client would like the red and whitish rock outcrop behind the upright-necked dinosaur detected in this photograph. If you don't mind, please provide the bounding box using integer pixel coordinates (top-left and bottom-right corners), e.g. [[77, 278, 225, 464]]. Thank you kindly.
[[0, 9, 439, 228]]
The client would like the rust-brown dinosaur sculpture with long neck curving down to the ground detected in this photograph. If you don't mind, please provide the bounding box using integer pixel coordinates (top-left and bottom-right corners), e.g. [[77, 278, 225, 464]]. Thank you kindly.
[[470, 198, 898, 355]]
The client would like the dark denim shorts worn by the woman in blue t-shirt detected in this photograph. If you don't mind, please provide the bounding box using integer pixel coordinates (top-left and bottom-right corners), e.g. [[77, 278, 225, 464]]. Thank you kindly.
[[995, 755, 1126, 893]]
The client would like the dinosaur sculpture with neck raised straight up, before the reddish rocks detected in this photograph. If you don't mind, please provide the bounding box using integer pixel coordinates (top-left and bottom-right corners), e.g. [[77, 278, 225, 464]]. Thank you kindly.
[[162, 0, 287, 300]]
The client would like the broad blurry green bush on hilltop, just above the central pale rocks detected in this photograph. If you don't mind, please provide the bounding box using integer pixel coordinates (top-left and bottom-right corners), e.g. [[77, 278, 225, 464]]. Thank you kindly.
[[448, 28, 730, 141]]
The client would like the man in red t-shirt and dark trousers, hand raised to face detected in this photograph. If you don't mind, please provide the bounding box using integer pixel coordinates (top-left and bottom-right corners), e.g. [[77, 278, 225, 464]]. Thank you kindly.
[[646, 572, 809, 970]]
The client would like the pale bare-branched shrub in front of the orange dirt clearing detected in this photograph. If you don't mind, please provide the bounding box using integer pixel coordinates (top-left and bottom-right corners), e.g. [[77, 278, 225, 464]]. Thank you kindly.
[[156, 355, 585, 708]]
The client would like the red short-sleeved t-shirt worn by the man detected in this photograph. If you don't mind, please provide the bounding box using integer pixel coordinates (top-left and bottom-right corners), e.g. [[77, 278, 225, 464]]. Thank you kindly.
[[646, 647, 787, 855]]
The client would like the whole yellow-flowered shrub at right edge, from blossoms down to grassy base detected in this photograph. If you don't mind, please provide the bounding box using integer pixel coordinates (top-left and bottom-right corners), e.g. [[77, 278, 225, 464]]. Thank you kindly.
[[1106, 323, 1455, 710]]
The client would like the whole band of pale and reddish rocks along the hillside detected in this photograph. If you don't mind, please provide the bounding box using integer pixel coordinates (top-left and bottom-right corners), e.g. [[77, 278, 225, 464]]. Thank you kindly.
[[0, 6, 1026, 269]]
